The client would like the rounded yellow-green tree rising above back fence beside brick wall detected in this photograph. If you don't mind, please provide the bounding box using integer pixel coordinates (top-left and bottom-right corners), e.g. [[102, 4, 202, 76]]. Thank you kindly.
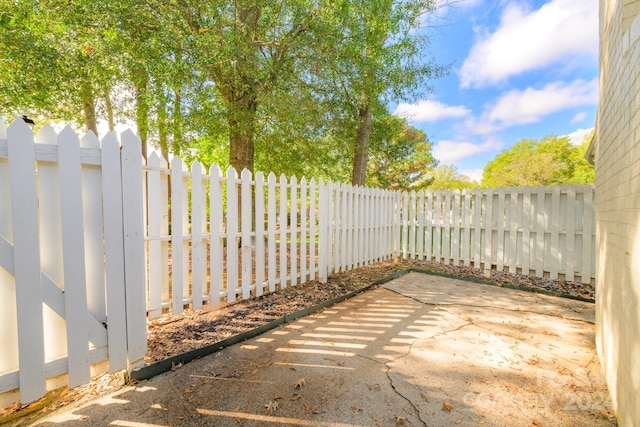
[[482, 133, 594, 188]]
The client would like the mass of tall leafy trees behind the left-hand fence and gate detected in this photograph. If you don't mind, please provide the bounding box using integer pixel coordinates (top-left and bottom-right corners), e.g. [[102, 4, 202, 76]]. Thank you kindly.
[[0, 0, 447, 184]]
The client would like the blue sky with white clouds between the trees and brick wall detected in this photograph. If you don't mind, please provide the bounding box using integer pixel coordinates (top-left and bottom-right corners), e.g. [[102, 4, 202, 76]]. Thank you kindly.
[[395, 0, 598, 181]]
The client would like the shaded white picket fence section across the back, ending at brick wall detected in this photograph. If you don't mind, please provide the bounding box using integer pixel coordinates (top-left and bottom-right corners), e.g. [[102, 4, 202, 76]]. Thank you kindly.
[[400, 186, 595, 283]]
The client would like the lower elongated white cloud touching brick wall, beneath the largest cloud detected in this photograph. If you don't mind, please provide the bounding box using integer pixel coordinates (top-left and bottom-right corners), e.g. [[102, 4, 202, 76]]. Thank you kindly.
[[488, 79, 598, 126]]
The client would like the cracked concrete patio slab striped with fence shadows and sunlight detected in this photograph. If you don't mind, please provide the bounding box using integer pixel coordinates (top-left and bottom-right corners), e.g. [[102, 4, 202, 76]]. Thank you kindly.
[[31, 273, 614, 427]]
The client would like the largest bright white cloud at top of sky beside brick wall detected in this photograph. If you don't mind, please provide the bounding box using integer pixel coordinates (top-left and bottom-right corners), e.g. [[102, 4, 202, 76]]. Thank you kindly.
[[460, 0, 598, 88]]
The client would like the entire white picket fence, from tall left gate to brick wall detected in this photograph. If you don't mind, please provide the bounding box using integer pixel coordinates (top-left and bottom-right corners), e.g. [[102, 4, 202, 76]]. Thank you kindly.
[[0, 120, 594, 407]]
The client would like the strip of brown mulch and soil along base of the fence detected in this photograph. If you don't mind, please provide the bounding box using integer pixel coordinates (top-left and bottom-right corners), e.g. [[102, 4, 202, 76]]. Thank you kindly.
[[0, 260, 595, 426]]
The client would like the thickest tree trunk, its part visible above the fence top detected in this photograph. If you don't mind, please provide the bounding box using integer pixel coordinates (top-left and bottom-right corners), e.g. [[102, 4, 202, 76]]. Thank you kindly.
[[228, 95, 258, 175]]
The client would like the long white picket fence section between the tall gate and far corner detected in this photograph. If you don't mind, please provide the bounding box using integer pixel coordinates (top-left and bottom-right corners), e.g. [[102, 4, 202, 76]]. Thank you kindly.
[[144, 153, 398, 318]]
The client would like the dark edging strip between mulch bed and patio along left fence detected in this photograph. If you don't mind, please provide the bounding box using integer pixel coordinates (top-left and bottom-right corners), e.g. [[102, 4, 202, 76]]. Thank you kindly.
[[130, 270, 411, 380]]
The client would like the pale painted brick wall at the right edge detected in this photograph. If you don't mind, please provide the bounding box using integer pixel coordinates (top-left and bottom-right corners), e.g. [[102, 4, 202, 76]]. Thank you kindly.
[[594, 0, 640, 426]]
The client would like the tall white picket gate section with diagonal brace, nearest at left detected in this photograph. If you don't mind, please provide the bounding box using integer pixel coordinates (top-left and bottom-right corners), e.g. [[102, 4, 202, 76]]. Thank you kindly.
[[0, 119, 146, 403]]
